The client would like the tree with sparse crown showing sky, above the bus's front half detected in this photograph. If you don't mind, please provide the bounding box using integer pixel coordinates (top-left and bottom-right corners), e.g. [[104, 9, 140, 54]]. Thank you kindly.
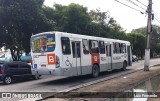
[[89, 9, 125, 39]]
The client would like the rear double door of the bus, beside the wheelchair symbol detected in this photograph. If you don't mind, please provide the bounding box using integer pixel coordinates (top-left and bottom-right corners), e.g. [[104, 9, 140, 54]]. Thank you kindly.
[[72, 41, 82, 76]]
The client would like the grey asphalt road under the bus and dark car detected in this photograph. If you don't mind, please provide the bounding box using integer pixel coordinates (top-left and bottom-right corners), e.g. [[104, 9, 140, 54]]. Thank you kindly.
[[0, 58, 160, 100]]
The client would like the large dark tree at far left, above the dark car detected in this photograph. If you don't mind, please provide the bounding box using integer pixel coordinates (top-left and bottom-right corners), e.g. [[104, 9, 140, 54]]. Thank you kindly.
[[0, 0, 54, 60]]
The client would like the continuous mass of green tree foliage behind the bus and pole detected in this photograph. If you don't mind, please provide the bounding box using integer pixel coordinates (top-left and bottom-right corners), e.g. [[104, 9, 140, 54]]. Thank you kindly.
[[0, 0, 160, 60]]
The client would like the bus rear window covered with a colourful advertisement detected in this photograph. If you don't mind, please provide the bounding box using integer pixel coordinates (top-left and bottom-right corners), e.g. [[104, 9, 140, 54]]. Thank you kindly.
[[31, 34, 55, 53]]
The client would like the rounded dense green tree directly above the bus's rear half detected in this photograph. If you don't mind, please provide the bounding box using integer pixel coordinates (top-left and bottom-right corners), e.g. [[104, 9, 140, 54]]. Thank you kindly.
[[53, 3, 91, 34]]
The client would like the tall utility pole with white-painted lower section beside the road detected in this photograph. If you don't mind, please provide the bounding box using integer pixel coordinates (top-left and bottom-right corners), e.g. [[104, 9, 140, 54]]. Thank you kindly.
[[144, 0, 152, 71]]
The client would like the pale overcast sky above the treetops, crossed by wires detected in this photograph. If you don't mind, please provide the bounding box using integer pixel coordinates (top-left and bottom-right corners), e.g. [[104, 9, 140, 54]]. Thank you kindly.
[[44, 0, 160, 32]]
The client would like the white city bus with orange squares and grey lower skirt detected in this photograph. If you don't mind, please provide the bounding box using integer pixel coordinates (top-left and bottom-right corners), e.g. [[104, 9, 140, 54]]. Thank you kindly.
[[31, 31, 132, 77]]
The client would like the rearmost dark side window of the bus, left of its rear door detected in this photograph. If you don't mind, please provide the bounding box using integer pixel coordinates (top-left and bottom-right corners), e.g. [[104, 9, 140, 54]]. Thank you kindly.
[[61, 37, 71, 55]]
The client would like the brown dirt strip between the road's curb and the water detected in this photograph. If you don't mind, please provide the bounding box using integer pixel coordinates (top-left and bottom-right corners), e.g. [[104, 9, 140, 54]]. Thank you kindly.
[[45, 66, 160, 101]]
